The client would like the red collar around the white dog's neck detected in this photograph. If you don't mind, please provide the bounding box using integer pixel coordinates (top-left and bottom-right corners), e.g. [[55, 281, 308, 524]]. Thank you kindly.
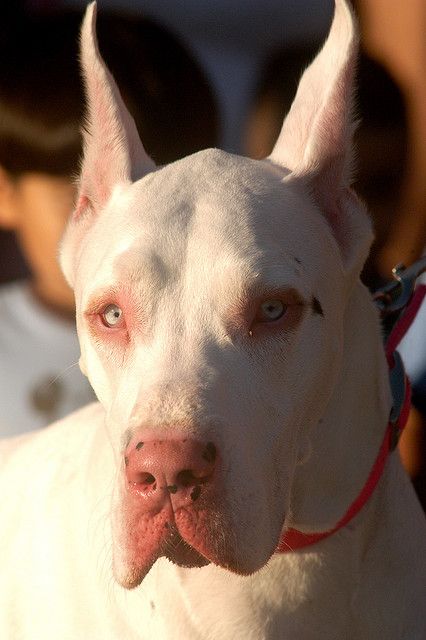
[[276, 285, 426, 553]]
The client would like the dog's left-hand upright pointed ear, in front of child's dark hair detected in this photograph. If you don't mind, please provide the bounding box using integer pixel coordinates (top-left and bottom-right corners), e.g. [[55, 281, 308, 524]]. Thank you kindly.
[[61, 2, 155, 285]]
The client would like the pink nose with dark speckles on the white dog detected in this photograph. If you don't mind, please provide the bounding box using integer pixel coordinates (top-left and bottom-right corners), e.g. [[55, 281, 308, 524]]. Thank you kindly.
[[125, 436, 217, 506]]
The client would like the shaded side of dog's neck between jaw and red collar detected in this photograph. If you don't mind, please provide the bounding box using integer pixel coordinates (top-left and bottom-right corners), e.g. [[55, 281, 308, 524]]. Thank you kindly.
[[287, 283, 392, 533]]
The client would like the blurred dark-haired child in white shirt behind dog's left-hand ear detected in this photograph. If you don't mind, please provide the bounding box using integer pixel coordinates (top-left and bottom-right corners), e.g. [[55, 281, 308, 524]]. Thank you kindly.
[[0, 6, 217, 436]]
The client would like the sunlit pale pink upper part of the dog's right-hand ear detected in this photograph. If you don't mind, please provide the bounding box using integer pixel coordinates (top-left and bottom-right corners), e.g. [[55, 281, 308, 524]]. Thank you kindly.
[[270, 0, 357, 185]]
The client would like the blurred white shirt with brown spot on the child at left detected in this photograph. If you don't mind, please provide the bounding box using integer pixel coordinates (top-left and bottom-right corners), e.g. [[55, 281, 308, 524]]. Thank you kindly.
[[0, 282, 94, 437]]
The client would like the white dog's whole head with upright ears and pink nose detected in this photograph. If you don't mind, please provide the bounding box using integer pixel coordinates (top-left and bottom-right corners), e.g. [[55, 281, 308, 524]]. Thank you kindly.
[[62, 3, 370, 586]]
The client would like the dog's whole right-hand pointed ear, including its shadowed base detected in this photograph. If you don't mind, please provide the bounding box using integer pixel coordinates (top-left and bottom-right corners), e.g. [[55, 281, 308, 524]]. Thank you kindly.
[[269, 0, 372, 276]]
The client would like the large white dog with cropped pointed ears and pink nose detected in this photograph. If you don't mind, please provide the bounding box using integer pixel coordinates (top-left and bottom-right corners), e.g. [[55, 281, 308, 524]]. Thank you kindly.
[[0, 0, 426, 640]]
